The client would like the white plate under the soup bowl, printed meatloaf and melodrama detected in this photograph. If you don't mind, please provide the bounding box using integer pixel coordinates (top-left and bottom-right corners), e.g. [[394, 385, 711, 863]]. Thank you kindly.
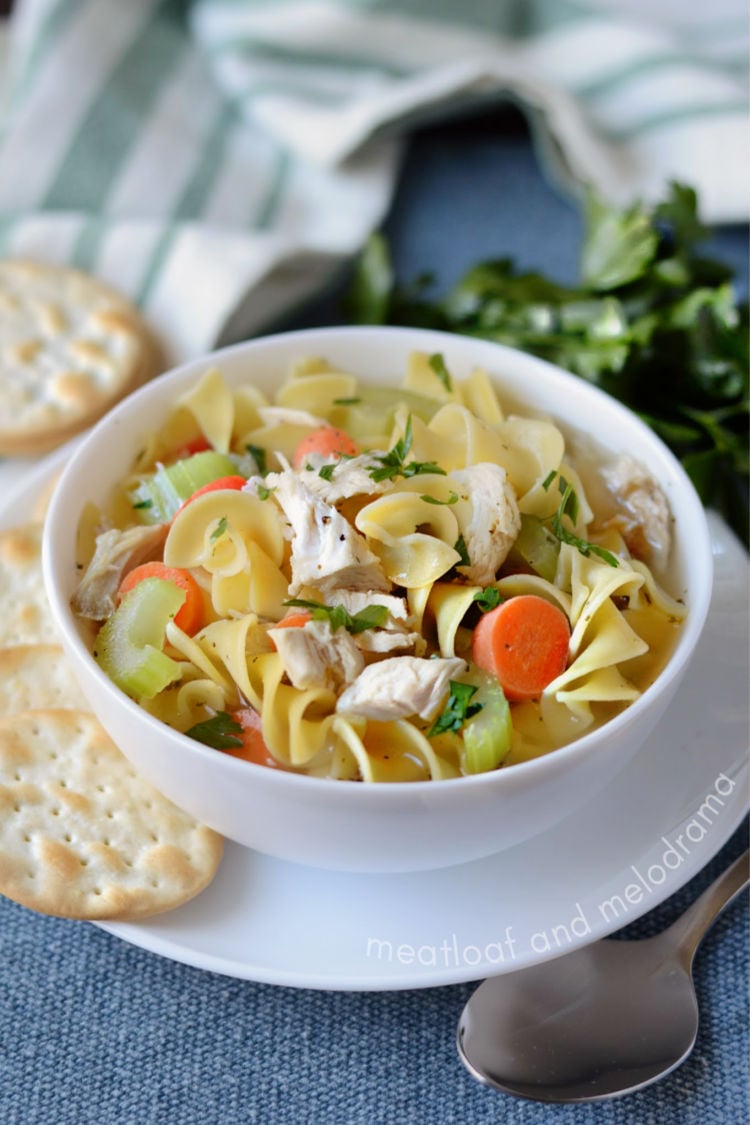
[[0, 453, 750, 990]]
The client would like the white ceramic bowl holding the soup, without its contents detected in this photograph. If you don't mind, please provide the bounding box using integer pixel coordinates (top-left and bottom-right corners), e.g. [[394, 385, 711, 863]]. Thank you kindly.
[[44, 327, 712, 872]]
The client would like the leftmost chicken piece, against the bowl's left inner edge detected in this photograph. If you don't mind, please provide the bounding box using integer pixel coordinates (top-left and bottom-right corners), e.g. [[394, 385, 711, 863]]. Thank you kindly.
[[73, 523, 169, 621]]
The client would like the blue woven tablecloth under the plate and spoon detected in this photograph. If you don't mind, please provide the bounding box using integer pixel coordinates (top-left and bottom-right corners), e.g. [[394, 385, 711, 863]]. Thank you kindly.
[[0, 116, 750, 1125]]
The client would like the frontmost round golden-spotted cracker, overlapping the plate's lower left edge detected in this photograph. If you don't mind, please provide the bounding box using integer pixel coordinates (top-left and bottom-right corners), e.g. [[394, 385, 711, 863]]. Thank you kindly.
[[0, 710, 224, 920]]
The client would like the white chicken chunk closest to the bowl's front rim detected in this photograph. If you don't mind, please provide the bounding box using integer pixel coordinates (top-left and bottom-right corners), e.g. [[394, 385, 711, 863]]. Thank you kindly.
[[336, 656, 467, 722]]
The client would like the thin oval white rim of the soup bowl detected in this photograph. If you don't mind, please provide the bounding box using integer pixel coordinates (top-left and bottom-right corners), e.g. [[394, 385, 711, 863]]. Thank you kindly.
[[42, 325, 713, 802]]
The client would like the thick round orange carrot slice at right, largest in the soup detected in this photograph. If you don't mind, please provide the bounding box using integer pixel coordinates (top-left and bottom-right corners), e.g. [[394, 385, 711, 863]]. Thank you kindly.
[[471, 594, 570, 702]]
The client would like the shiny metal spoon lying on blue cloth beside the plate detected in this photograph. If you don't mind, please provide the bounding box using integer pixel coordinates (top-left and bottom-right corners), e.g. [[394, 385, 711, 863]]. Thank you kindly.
[[458, 852, 750, 1103]]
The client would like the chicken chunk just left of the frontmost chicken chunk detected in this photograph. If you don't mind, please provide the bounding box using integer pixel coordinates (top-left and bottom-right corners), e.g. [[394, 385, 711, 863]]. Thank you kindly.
[[269, 621, 364, 691]]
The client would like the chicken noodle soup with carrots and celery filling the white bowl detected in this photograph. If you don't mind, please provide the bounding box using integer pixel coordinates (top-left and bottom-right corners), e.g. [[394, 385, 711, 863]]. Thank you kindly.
[[74, 353, 686, 782]]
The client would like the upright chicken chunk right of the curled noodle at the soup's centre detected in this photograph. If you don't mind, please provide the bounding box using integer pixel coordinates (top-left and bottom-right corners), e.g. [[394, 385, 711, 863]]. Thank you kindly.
[[449, 461, 521, 586]]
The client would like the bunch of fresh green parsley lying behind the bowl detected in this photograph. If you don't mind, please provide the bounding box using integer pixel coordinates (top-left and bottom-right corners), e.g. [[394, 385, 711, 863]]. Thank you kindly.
[[347, 183, 750, 541]]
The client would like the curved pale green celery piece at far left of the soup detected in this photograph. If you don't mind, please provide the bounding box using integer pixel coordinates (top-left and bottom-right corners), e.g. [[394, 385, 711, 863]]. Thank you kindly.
[[93, 578, 186, 700]]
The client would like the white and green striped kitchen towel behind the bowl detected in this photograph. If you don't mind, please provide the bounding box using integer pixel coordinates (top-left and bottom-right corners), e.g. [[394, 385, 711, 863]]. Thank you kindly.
[[0, 0, 750, 360]]
